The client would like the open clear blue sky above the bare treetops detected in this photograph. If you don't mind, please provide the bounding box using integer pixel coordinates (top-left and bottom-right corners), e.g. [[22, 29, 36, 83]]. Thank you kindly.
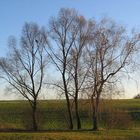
[[0, 0, 140, 99]]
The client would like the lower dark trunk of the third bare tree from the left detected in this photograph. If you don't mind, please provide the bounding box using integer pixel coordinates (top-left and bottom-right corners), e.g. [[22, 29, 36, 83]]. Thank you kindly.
[[74, 99, 81, 129]]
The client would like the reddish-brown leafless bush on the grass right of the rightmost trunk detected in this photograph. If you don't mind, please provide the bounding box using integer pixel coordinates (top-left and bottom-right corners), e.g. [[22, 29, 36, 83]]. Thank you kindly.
[[100, 100, 132, 129]]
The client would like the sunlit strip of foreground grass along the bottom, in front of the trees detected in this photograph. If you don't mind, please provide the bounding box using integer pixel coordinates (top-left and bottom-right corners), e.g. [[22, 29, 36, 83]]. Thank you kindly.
[[0, 130, 140, 140]]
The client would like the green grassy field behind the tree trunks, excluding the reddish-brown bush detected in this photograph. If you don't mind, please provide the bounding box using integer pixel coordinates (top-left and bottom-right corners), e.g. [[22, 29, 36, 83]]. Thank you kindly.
[[0, 99, 140, 130]]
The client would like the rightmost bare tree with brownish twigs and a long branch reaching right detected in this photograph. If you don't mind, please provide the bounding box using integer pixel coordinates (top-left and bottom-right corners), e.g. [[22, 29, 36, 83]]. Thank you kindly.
[[87, 18, 139, 130]]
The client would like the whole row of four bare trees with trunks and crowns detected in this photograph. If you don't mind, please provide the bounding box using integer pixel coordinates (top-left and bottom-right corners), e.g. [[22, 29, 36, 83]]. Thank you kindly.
[[0, 8, 140, 130]]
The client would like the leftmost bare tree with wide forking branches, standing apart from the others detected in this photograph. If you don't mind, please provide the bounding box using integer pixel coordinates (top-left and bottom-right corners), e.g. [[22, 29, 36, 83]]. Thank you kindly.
[[0, 23, 47, 131]]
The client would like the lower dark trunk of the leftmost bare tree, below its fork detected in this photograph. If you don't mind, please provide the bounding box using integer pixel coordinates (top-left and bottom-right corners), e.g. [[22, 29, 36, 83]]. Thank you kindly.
[[32, 101, 38, 131]]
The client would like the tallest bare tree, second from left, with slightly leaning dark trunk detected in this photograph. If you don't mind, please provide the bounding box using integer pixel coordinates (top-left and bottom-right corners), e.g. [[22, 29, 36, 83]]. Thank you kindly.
[[47, 9, 77, 129]]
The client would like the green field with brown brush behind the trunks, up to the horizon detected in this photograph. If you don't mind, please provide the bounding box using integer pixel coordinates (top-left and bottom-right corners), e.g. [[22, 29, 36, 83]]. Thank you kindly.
[[0, 99, 140, 131]]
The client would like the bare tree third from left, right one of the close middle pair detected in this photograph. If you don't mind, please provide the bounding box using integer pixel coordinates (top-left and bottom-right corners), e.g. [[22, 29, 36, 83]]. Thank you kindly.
[[67, 16, 94, 129]]
